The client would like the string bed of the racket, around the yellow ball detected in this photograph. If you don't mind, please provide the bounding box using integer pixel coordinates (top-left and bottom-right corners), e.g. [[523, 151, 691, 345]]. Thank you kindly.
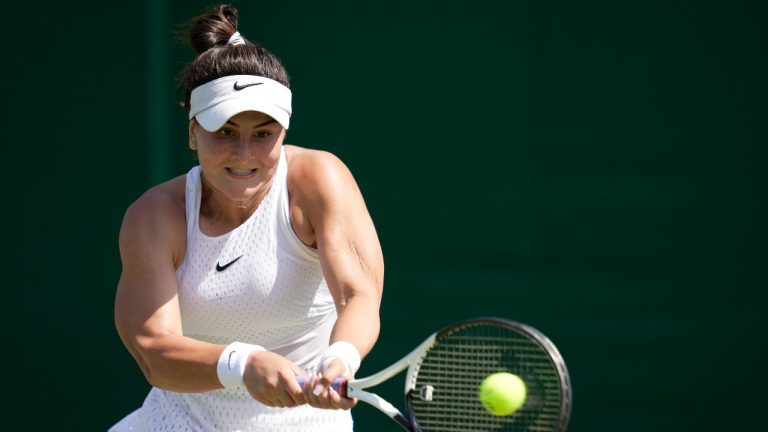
[[410, 323, 562, 432]]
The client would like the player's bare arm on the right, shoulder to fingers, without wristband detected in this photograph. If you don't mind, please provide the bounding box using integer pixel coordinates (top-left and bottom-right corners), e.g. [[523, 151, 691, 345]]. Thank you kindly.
[[289, 149, 384, 404]]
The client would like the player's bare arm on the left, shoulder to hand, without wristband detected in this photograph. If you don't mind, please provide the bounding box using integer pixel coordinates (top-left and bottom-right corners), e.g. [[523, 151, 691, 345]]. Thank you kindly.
[[115, 183, 304, 406]]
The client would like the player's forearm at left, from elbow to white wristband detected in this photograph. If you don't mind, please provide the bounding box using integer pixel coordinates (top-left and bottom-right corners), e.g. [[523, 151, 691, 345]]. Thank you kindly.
[[129, 335, 224, 393]]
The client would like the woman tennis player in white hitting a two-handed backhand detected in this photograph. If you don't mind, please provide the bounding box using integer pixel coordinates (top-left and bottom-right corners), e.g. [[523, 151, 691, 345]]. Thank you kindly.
[[111, 6, 384, 432]]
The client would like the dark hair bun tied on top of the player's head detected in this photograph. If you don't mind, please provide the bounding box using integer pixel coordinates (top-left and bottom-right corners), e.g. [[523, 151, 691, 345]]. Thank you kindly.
[[189, 5, 237, 54]]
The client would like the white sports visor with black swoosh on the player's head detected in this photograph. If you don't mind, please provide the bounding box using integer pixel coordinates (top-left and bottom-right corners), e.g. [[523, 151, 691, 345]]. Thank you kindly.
[[189, 75, 291, 132]]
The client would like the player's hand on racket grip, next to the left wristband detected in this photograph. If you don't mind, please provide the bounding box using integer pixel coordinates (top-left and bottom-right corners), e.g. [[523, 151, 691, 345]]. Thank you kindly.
[[243, 351, 307, 408]]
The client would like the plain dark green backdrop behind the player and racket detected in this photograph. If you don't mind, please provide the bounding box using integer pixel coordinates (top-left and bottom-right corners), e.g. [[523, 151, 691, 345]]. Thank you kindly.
[[0, 0, 768, 432]]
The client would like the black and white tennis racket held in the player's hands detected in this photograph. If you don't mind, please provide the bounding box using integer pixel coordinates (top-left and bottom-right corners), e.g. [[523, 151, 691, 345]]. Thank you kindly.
[[297, 318, 571, 432]]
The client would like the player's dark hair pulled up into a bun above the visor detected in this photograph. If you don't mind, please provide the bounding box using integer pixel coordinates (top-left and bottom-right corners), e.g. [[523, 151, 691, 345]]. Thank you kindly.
[[177, 5, 289, 112]]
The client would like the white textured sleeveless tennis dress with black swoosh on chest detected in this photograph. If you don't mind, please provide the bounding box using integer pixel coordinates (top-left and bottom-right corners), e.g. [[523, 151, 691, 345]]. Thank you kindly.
[[126, 150, 352, 432]]
